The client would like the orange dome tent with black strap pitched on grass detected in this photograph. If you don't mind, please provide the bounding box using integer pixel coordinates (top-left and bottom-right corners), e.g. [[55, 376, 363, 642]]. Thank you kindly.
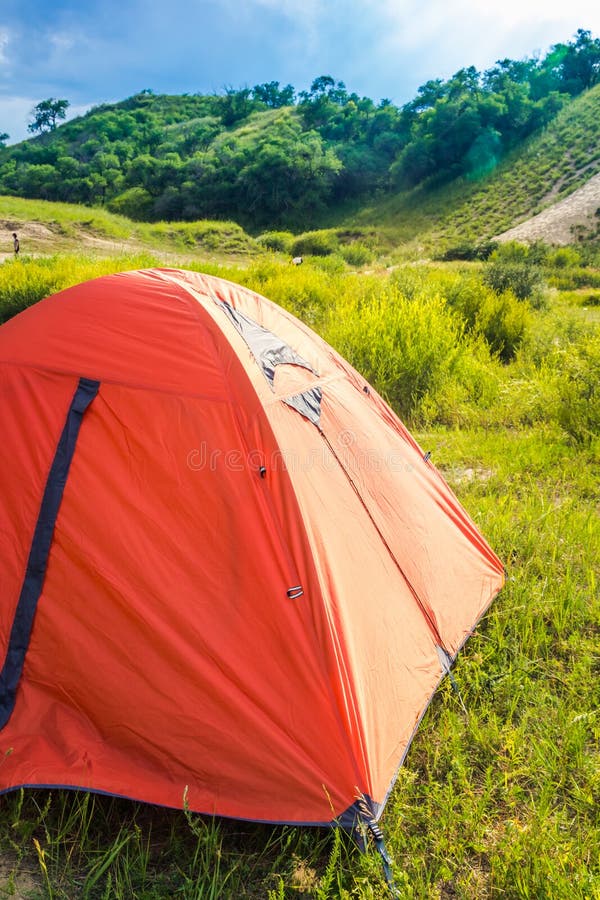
[[0, 269, 503, 836]]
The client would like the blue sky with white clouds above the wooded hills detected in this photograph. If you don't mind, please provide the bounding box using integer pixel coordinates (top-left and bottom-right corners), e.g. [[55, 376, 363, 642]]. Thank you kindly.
[[0, 0, 600, 143]]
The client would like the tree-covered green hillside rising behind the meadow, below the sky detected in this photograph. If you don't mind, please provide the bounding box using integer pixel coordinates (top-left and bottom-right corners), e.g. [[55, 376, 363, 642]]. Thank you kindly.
[[0, 29, 600, 241]]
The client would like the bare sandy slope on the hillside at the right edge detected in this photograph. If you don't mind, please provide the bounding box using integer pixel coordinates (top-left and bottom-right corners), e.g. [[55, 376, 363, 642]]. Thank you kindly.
[[496, 173, 600, 245]]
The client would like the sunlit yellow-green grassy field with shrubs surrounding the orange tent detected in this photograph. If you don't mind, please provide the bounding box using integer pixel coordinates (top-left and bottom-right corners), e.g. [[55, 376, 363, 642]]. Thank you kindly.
[[0, 252, 600, 900]]
